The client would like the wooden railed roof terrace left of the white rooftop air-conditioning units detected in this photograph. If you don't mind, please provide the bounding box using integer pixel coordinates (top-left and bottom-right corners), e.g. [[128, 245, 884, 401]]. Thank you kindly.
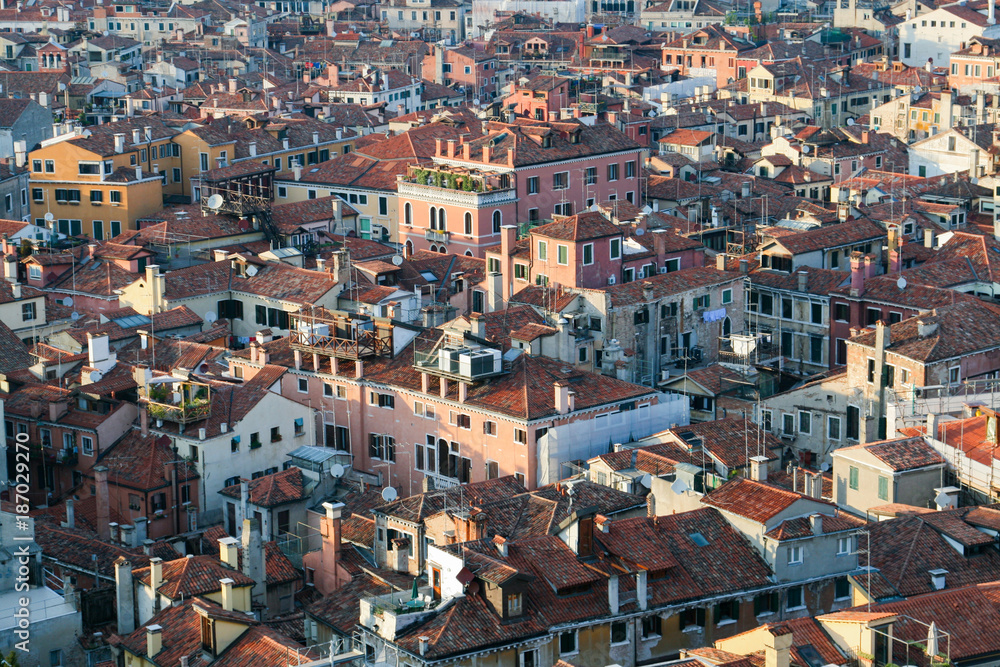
[[289, 311, 393, 359]]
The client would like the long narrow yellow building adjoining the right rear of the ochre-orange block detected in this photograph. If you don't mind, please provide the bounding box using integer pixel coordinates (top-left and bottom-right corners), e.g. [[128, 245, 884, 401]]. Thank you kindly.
[[174, 116, 357, 202]]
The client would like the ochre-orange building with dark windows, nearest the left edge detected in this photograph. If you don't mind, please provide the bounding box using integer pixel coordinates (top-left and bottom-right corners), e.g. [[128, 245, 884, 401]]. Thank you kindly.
[[29, 119, 181, 240]]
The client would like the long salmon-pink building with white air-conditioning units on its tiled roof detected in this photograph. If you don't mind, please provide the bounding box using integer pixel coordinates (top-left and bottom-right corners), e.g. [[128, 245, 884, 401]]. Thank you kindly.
[[230, 307, 658, 495]]
